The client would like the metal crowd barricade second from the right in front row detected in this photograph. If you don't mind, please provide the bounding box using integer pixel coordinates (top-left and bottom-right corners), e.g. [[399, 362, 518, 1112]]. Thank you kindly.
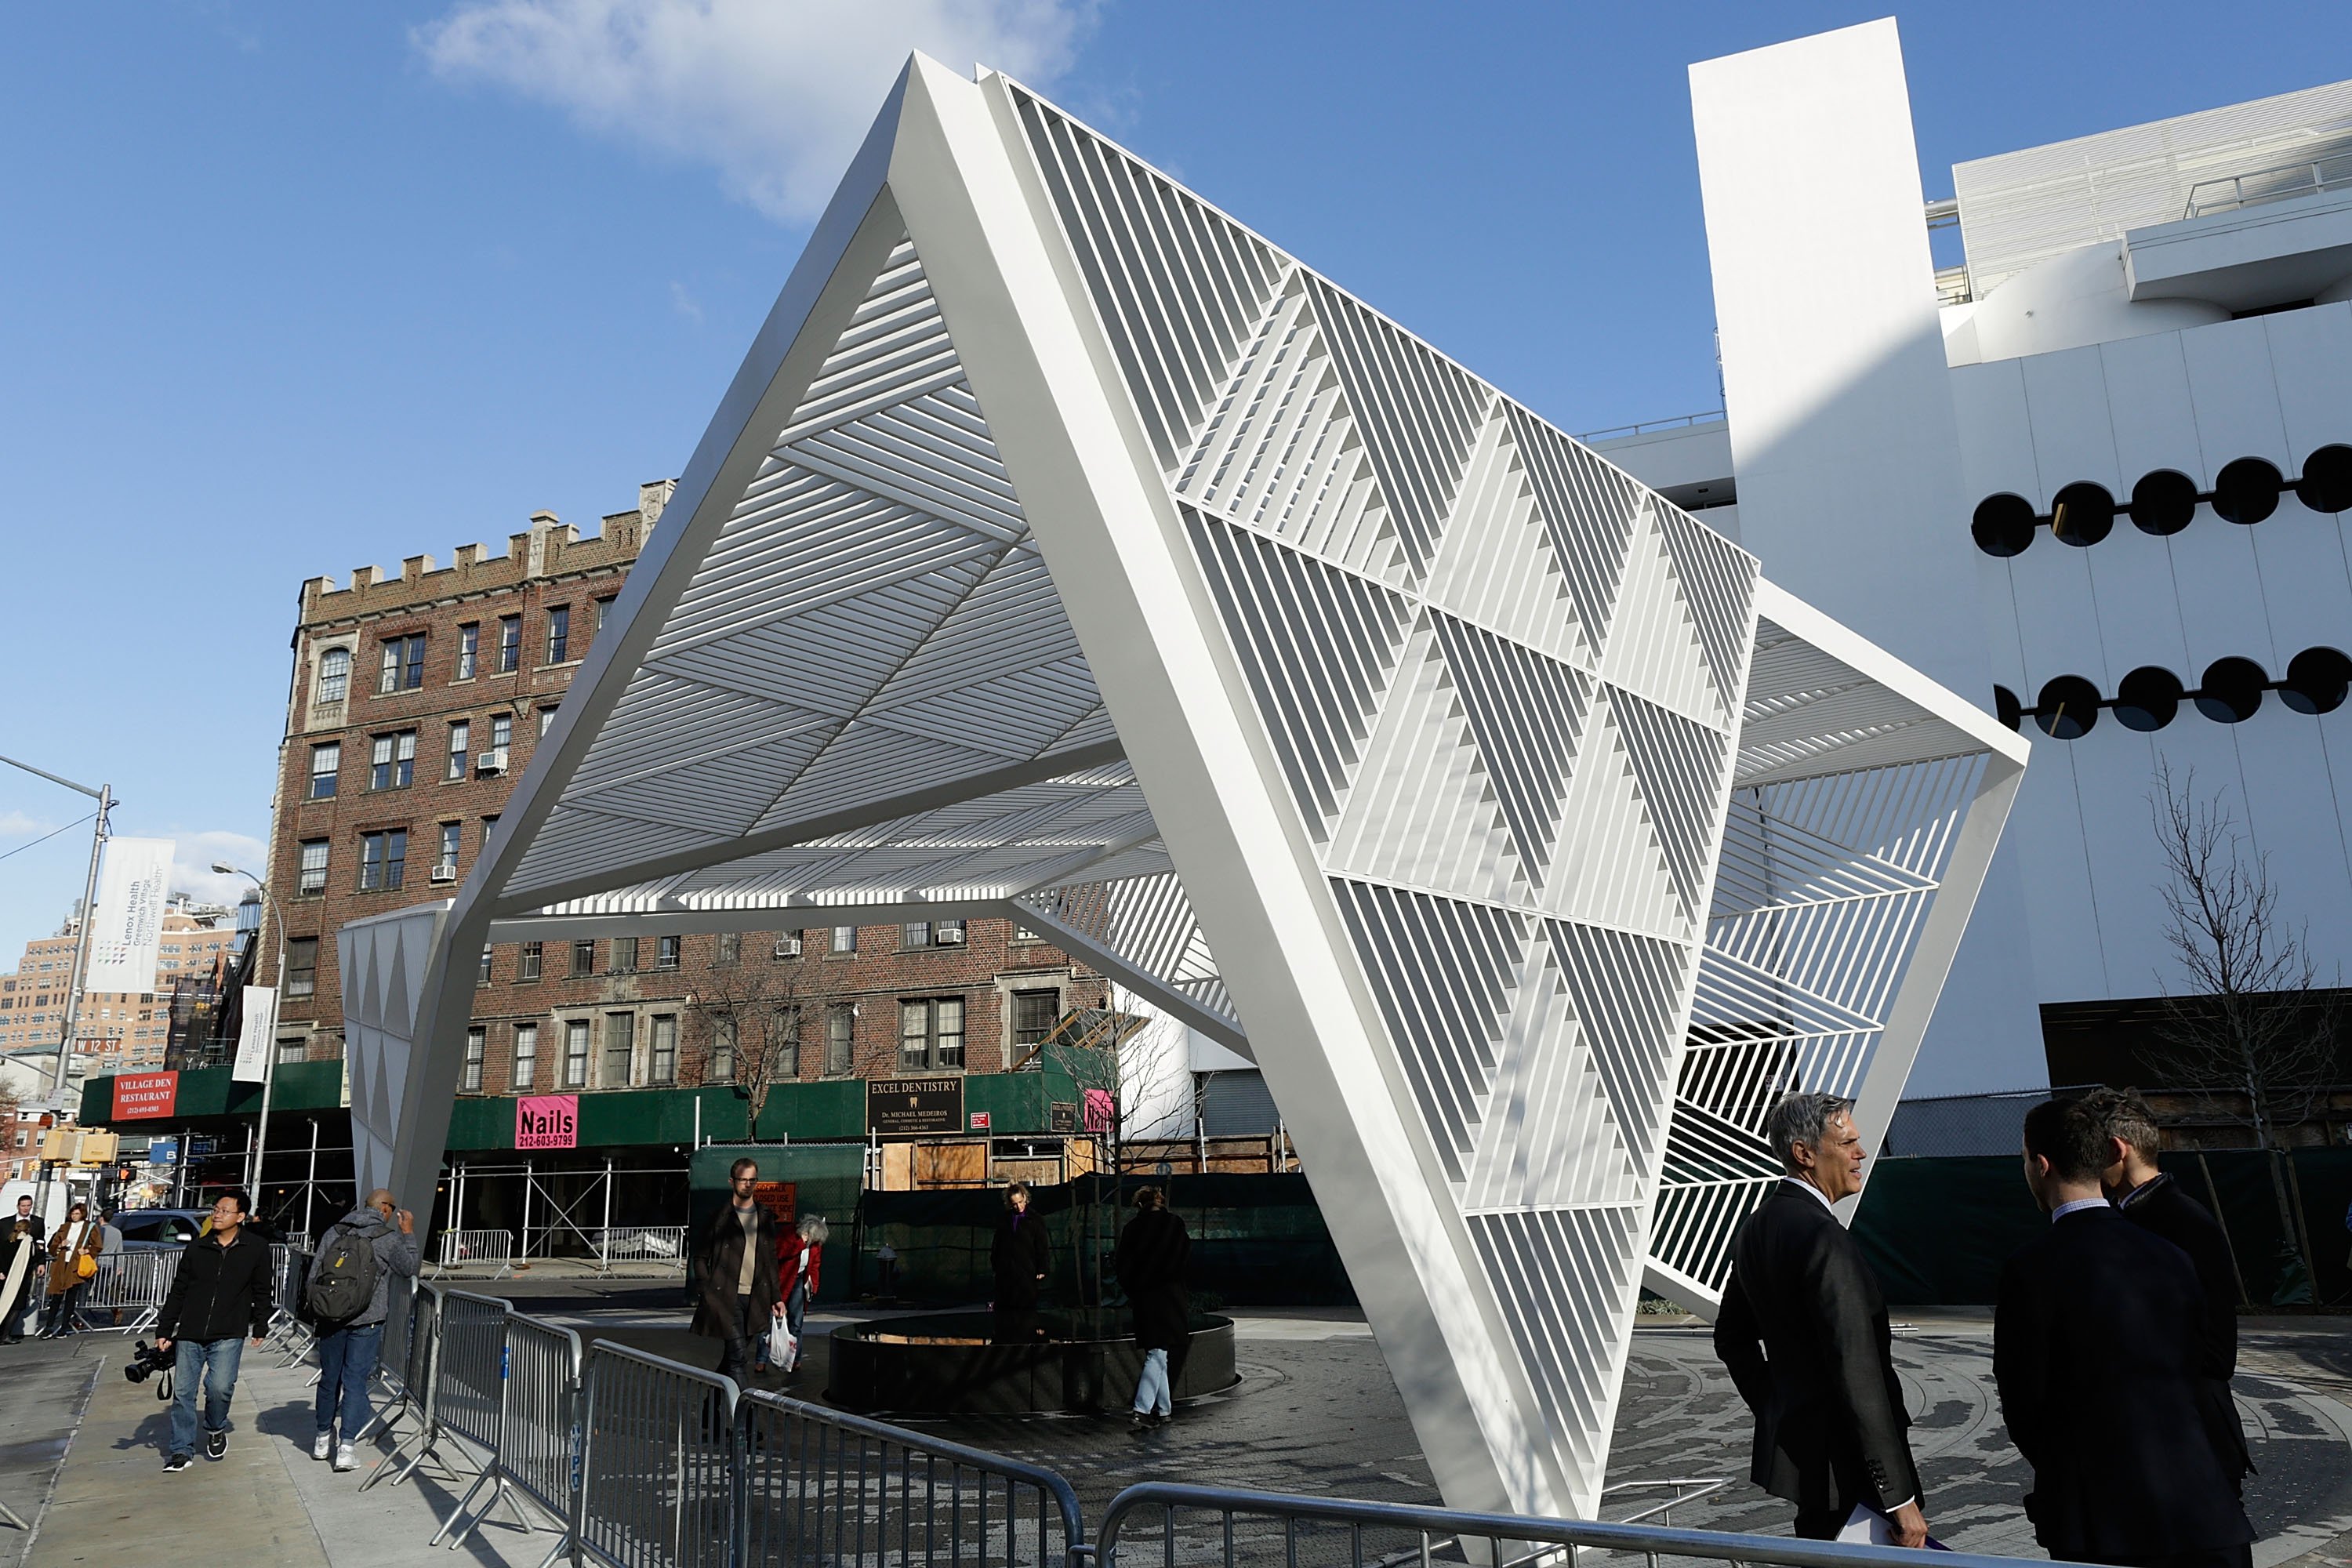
[[736, 1392, 1087, 1568]]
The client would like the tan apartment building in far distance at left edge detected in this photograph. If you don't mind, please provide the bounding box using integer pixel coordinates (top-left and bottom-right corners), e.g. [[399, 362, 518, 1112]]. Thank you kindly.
[[0, 898, 238, 1081]]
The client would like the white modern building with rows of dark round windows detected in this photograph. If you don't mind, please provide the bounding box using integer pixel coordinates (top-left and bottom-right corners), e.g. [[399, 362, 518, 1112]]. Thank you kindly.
[[1595, 21, 2352, 1093]]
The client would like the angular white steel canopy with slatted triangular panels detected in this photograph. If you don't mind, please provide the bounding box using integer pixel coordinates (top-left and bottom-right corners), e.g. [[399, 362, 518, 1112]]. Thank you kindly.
[[341, 56, 2025, 1512]]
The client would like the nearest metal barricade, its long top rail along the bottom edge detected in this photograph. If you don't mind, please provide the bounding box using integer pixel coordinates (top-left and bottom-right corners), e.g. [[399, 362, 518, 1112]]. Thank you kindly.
[[1096, 1481, 2089, 1568]]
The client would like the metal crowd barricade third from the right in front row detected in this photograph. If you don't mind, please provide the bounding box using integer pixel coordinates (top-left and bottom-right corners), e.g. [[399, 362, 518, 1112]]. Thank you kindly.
[[562, 1340, 741, 1568]]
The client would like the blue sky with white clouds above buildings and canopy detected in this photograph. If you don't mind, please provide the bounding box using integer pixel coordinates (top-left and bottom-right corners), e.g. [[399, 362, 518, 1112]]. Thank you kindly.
[[0, 0, 2352, 982]]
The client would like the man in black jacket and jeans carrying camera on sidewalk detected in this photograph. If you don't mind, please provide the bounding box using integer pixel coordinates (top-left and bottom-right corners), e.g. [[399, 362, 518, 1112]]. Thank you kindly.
[[155, 1187, 273, 1474]]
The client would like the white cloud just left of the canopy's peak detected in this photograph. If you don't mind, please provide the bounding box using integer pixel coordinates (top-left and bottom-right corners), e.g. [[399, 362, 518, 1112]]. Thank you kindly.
[[414, 0, 1094, 221]]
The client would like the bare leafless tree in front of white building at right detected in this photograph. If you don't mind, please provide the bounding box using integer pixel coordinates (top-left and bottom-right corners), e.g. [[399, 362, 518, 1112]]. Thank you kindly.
[[2150, 762, 2336, 1279]]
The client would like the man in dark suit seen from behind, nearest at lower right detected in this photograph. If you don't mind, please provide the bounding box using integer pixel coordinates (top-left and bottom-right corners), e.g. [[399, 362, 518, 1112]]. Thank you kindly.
[[1992, 1100, 2253, 1568]]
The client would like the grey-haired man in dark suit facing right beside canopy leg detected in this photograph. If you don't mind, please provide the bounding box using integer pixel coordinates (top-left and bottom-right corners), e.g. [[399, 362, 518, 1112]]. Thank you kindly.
[[1715, 1093, 1926, 1547]]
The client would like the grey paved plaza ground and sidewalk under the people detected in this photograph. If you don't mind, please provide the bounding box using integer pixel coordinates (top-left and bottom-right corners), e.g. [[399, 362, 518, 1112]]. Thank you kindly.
[[0, 1276, 2352, 1568]]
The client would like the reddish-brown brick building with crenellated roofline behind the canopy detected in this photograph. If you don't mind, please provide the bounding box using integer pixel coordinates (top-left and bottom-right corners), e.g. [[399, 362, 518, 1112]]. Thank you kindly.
[[261, 482, 1105, 1109]]
